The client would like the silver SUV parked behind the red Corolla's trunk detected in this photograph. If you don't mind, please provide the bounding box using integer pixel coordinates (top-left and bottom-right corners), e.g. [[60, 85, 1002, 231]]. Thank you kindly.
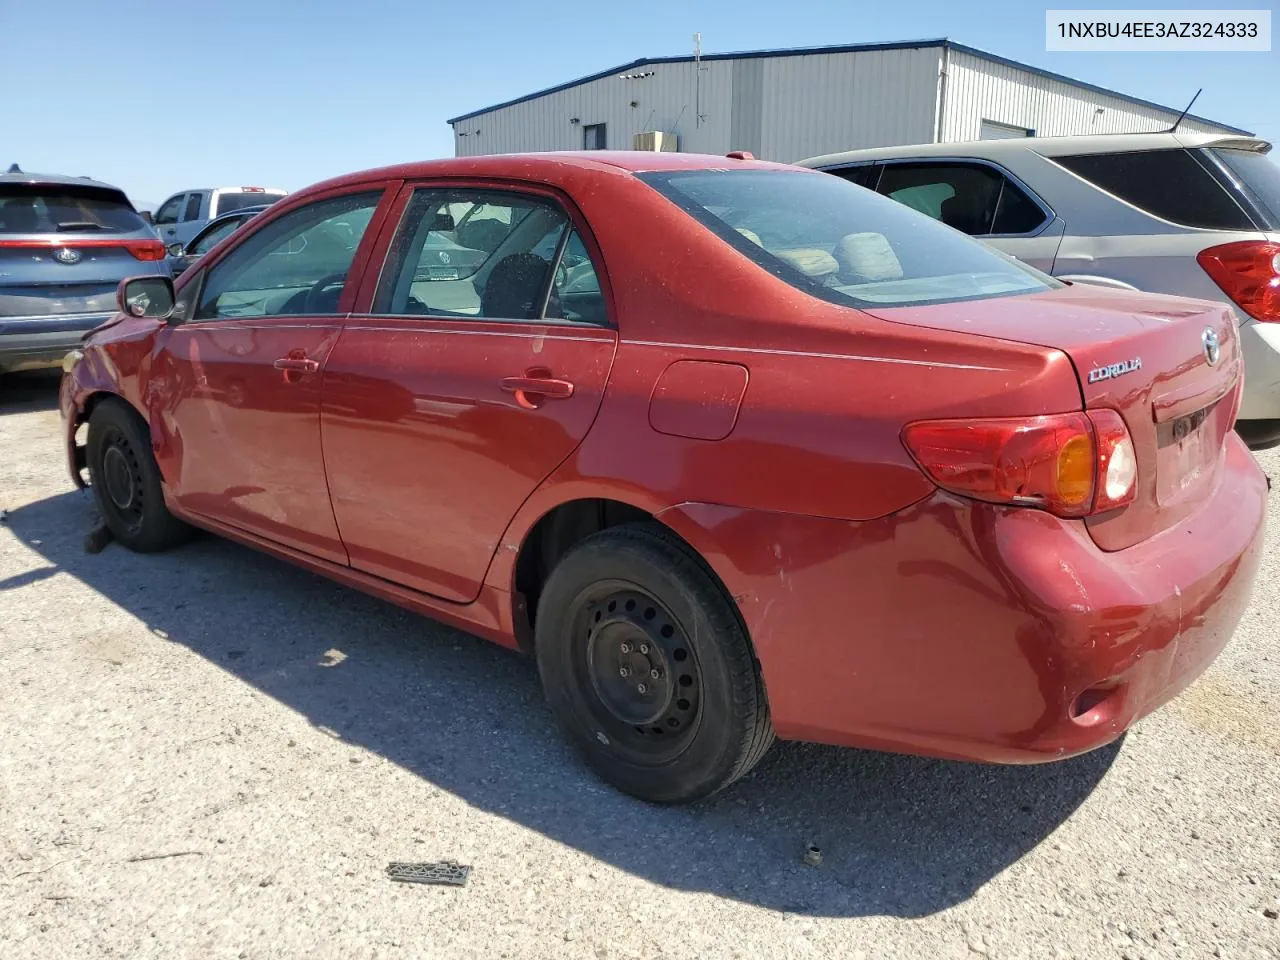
[[801, 133, 1280, 449]]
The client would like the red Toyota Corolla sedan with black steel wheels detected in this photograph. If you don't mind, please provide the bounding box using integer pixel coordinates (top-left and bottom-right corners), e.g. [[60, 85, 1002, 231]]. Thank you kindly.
[[61, 152, 1267, 801]]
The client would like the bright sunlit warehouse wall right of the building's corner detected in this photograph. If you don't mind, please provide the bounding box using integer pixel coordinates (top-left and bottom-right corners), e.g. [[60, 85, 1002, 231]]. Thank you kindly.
[[941, 50, 1226, 142]]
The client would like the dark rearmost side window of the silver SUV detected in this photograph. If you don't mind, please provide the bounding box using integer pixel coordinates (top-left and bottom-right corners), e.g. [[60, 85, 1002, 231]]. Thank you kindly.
[[1051, 150, 1256, 230]]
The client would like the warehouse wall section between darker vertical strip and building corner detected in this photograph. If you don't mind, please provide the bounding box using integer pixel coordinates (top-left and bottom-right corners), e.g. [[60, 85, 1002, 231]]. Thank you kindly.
[[760, 47, 942, 163]]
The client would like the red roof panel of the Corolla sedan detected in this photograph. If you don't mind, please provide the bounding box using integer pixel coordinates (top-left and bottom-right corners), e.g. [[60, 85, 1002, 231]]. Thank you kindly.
[[293, 150, 796, 196]]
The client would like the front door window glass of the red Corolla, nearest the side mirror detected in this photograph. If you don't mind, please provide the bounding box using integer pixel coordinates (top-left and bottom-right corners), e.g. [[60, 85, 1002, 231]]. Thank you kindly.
[[195, 191, 383, 320]]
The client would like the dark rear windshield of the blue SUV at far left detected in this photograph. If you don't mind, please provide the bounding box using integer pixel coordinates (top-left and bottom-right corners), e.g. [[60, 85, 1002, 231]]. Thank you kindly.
[[0, 183, 148, 234]]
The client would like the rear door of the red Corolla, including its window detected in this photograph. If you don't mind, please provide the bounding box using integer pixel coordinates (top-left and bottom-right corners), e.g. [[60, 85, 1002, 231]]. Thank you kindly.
[[321, 183, 617, 602]]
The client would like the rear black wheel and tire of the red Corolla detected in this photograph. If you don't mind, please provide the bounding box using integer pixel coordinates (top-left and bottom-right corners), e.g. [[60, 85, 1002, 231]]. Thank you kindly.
[[534, 524, 773, 804]]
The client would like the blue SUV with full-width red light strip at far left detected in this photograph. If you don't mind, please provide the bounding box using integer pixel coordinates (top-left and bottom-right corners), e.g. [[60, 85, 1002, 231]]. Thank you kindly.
[[0, 165, 165, 374]]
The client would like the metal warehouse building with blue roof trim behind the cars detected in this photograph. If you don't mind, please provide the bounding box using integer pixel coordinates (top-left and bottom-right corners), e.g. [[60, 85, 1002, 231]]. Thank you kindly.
[[449, 40, 1247, 161]]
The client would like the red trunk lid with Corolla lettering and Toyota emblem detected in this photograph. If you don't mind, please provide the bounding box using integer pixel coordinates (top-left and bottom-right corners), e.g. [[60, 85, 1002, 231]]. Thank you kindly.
[[867, 285, 1242, 550]]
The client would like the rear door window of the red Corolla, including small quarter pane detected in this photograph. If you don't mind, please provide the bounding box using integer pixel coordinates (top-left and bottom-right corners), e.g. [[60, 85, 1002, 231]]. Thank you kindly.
[[374, 188, 604, 321]]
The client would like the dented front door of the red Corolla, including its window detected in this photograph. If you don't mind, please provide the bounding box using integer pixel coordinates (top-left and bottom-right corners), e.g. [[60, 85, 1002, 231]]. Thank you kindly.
[[155, 188, 383, 563]]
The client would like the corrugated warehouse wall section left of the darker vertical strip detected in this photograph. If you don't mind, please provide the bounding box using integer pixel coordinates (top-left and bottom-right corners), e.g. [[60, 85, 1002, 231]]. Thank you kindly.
[[453, 60, 733, 156]]
